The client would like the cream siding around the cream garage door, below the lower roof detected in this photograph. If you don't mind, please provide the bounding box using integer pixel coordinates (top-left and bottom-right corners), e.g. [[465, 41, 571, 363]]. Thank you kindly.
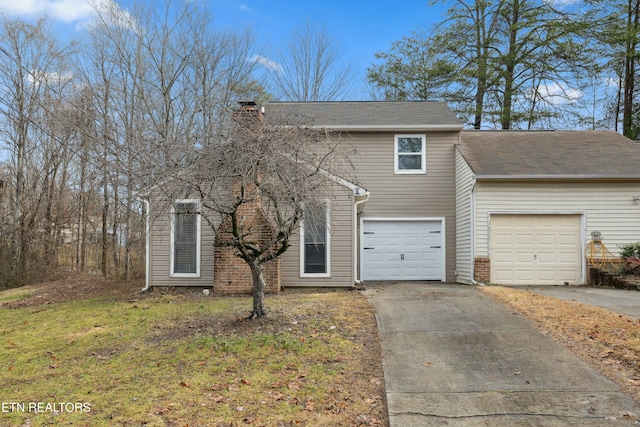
[[475, 181, 640, 256]]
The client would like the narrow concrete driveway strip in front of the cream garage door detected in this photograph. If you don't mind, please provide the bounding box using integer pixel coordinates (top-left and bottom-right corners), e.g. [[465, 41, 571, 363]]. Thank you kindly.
[[518, 286, 640, 319]]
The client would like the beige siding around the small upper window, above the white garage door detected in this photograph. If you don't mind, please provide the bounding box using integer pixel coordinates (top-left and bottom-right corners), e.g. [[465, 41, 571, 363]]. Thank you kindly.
[[349, 132, 459, 281]]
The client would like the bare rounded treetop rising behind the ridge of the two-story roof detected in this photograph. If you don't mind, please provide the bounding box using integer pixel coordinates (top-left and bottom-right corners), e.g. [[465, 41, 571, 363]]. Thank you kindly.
[[272, 22, 353, 101]]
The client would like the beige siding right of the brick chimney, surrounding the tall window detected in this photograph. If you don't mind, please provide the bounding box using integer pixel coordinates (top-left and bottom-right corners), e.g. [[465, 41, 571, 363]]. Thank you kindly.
[[280, 184, 354, 287]]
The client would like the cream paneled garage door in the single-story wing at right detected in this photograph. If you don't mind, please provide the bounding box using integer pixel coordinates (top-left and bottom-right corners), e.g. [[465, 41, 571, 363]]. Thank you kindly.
[[490, 215, 582, 285]]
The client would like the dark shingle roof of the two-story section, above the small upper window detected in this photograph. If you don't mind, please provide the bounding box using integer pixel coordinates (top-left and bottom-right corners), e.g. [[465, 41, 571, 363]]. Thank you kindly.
[[264, 101, 462, 131]]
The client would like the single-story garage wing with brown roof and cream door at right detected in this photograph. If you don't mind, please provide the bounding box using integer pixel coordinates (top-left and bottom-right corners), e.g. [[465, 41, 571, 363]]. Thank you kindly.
[[455, 131, 640, 286]]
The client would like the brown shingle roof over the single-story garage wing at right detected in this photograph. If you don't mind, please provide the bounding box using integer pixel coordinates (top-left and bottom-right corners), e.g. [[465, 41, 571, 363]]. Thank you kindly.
[[457, 131, 640, 179]]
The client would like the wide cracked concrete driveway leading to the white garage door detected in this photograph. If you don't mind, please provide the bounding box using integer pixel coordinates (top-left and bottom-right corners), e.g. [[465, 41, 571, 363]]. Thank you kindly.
[[364, 282, 640, 427]]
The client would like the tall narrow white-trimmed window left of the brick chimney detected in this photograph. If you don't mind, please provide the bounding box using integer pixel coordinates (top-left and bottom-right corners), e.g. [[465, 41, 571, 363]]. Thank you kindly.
[[171, 199, 201, 277]]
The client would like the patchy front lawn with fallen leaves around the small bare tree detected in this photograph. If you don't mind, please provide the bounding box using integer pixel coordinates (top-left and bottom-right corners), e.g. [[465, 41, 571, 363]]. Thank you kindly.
[[0, 284, 387, 427]]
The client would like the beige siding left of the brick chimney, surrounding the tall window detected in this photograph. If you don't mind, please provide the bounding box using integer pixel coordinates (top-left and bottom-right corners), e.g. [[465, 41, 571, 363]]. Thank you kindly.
[[149, 198, 219, 286]]
